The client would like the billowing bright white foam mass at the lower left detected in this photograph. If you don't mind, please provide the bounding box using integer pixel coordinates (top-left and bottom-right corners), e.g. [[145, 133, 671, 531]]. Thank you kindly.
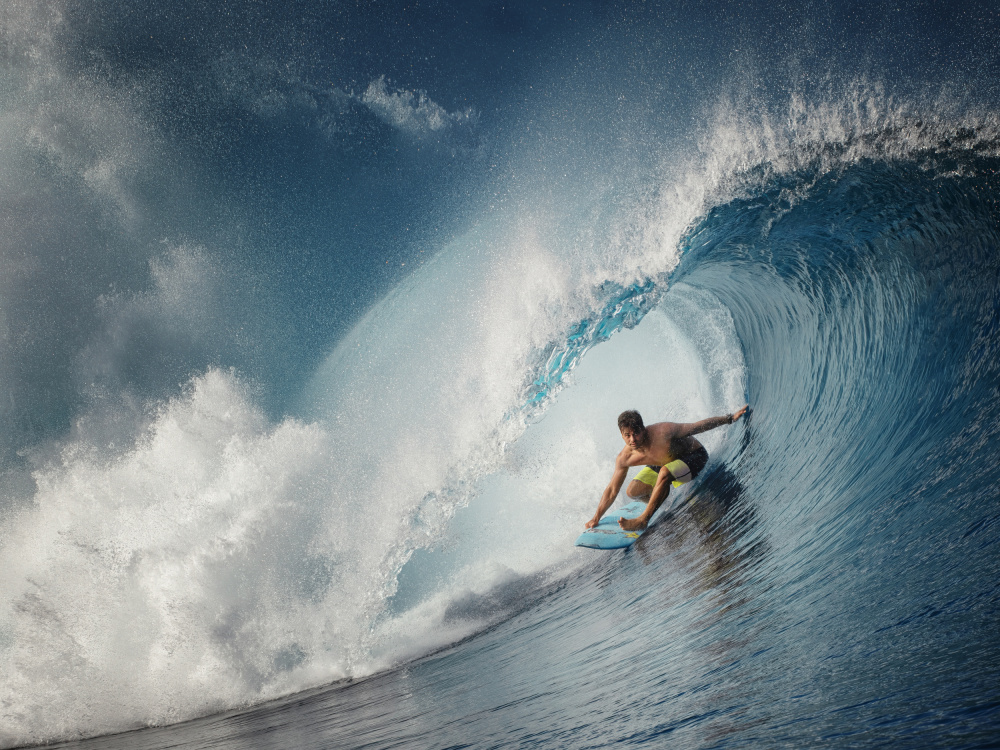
[[0, 371, 323, 742]]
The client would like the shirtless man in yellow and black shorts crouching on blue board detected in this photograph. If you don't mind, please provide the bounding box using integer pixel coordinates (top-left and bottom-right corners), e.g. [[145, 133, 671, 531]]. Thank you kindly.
[[587, 406, 747, 531]]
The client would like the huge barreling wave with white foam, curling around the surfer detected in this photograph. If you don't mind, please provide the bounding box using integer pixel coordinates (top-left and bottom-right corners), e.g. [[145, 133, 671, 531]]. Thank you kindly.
[[0, 78, 1000, 745]]
